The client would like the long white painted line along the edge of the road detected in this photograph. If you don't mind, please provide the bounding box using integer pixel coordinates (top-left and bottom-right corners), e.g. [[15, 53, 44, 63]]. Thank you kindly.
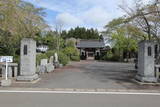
[[0, 90, 160, 96]]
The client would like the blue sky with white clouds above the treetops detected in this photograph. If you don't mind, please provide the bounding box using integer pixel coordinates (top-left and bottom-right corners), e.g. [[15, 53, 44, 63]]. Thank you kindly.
[[25, 0, 151, 31]]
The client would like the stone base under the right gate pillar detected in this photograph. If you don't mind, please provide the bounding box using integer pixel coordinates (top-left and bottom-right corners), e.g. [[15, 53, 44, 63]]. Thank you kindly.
[[136, 75, 158, 83]]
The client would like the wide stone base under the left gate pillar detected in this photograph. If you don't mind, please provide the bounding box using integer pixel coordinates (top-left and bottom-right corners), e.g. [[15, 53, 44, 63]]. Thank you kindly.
[[17, 74, 38, 81]]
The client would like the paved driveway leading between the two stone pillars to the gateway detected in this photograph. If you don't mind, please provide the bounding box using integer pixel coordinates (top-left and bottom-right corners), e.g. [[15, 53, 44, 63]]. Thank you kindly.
[[9, 60, 160, 90]]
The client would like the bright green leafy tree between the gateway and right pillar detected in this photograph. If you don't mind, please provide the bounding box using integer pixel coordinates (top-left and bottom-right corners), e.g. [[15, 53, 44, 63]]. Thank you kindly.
[[109, 28, 138, 61]]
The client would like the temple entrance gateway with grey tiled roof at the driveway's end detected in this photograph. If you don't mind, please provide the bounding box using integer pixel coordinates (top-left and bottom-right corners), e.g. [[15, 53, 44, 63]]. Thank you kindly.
[[77, 40, 106, 60]]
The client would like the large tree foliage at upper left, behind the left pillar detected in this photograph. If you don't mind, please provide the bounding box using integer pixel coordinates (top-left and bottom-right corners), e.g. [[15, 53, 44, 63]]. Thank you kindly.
[[0, 0, 47, 56]]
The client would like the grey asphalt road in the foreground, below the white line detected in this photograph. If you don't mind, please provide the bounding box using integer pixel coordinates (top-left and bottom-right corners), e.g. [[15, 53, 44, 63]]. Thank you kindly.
[[0, 93, 160, 107]]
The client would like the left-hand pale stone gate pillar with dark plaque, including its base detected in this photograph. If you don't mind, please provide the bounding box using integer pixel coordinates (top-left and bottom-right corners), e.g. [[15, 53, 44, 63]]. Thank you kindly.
[[17, 38, 38, 81]]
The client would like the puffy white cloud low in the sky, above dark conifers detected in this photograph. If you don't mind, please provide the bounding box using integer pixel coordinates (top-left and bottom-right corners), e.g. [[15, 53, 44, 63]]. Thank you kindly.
[[56, 13, 83, 26]]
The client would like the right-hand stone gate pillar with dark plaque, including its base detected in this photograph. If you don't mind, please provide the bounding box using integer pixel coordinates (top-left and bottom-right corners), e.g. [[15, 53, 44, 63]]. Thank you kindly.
[[136, 41, 157, 82]]
